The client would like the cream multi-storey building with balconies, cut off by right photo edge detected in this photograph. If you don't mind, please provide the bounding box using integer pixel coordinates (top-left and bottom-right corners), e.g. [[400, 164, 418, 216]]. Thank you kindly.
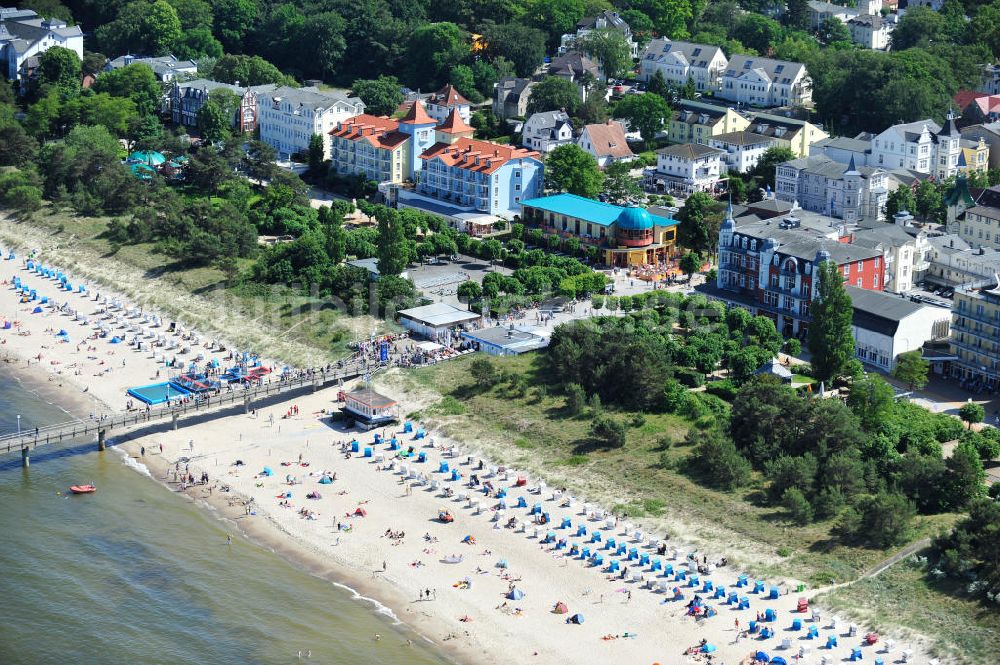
[[951, 279, 1000, 391]]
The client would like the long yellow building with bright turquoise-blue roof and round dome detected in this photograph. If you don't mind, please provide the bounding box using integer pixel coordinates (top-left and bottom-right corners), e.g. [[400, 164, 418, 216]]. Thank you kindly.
[[521, 194, 677, 268]]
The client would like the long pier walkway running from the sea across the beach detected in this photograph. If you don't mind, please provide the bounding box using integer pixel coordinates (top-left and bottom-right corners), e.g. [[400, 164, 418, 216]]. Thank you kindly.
[[0, 363, 386, 466]]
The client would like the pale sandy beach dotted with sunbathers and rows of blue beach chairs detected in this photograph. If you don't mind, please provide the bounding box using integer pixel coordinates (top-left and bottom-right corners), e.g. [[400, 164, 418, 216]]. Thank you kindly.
[[0, 258, 926, 665]]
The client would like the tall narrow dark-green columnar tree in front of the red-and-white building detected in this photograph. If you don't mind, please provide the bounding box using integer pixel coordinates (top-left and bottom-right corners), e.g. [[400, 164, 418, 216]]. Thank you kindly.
[[808, 261, 854, 381]]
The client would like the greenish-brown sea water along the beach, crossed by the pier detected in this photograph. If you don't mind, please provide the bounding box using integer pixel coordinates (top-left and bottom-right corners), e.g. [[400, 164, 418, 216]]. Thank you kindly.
[[0, 368, 448, 665]]
